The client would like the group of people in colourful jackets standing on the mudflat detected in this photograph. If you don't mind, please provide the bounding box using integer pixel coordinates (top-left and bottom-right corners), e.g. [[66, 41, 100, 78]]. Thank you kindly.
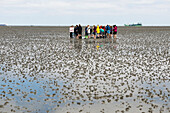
[[70, 24, 117, 39]]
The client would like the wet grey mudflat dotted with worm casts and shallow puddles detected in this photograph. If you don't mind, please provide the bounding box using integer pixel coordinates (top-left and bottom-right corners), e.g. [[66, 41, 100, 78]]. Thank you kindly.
[[0, 26, 170, 113]]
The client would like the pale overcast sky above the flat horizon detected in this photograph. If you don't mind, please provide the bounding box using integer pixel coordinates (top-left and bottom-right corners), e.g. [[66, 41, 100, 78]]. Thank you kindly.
[[0, 0, 170, 26]]
